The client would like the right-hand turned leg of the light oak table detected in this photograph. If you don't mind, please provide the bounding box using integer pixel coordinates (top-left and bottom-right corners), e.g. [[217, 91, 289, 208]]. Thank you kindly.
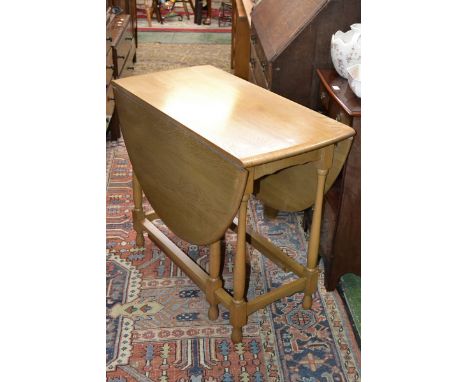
[[302, 169, 328, 309]]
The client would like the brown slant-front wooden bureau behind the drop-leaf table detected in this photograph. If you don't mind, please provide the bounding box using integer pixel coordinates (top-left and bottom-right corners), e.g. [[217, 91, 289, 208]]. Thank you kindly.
[[250, 0, 361, 109]]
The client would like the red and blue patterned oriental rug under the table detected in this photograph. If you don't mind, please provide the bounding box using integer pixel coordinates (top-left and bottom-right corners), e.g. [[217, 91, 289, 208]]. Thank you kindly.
[[106, 141, 360, 382]]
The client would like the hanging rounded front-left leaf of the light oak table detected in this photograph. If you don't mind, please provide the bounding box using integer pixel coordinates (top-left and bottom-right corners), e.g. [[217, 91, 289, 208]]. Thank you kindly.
[[115, 87, 247, 244]]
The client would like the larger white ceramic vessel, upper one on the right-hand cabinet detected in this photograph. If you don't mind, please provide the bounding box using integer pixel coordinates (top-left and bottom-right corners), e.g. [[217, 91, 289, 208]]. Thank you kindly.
[[331, 24, 361, 78]]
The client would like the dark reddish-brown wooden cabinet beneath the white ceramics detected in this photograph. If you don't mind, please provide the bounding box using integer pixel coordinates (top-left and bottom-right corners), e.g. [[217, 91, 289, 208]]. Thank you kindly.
[[317, 69, 361, 291]]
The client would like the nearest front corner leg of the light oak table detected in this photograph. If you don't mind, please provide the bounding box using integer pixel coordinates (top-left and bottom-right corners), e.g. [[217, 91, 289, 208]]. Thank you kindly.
[[230, 195, 249, 343]]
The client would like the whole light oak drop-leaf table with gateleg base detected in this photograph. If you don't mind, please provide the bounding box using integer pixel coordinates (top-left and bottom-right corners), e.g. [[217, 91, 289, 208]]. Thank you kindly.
[[113, 65, 355, 342]]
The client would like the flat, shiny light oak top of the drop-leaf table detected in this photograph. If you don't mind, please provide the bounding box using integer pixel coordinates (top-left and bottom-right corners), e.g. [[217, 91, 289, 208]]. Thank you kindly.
[[113, 65, 354, 168]]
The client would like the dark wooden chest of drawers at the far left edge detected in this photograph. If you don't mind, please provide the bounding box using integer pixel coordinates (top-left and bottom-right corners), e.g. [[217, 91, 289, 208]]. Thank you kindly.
[[106, 11, 136, 140]]
